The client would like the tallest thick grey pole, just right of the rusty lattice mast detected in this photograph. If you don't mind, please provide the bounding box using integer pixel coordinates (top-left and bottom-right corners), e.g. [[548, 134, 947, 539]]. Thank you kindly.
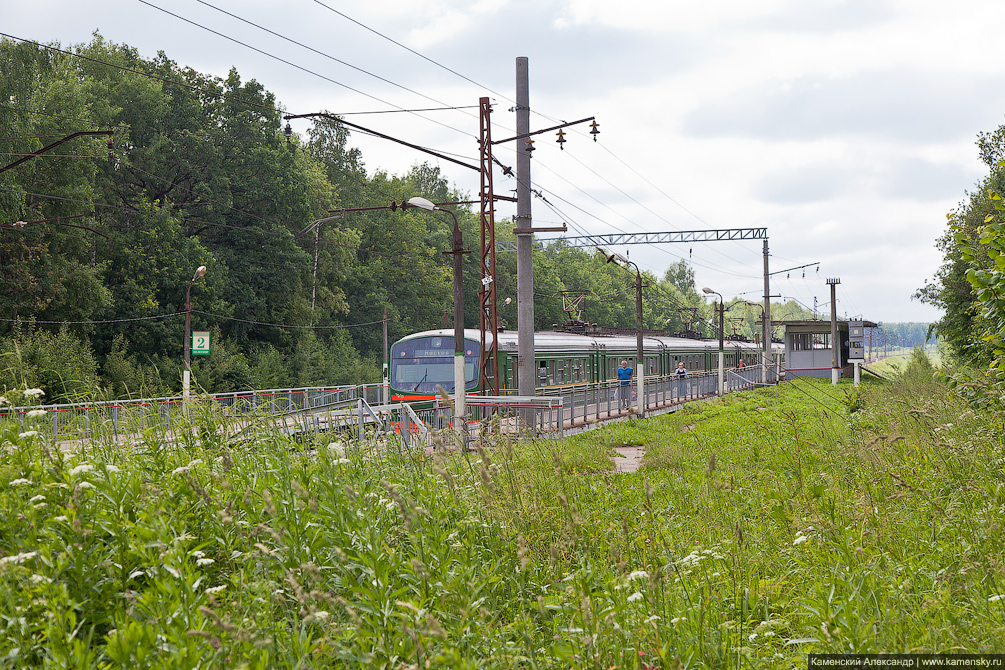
[[517, 56, 536, 397]]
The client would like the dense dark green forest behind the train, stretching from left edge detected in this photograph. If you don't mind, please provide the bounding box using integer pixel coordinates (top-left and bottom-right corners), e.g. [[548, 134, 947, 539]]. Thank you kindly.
[[0, 36, 924, 402]]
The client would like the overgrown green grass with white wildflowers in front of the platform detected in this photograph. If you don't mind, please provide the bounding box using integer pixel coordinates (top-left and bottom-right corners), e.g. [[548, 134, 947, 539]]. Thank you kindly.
[[0, 353, 1005, 668]]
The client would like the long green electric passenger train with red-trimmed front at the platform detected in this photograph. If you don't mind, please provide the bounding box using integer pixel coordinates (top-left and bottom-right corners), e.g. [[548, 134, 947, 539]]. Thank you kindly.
[[389, 328, 783, 402]]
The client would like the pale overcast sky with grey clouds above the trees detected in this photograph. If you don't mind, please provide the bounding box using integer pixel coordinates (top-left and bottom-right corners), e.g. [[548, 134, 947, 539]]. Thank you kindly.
[[7, 0, 1005, 321]]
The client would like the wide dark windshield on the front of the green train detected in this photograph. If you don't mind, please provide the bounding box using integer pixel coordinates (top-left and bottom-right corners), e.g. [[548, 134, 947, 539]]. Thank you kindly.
[[391, 336, 478, 393]]
